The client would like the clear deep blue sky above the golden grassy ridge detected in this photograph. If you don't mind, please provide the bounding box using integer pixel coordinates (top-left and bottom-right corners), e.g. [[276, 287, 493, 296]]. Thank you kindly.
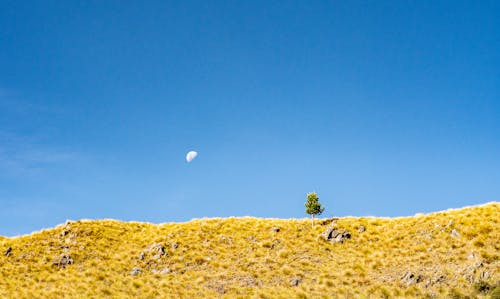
[[0, 1, 500, 235]]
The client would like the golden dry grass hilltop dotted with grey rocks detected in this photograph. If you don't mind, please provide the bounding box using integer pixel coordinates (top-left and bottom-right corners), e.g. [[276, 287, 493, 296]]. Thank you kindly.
[[0, 203, 500, 298]]
